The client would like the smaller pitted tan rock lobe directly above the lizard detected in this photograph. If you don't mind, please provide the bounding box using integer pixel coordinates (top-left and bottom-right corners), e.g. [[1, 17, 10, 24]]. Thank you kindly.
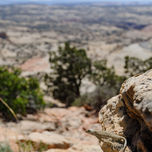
[[99, 95, 126, 135]]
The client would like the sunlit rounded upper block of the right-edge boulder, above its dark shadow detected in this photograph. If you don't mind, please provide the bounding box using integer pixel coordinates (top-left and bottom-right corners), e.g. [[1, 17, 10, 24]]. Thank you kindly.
[[121, 70, 152, 131]]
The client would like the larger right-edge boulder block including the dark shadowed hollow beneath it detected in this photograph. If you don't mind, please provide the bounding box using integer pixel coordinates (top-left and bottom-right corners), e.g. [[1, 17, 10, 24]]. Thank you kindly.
[[121, 70, 152, 152]]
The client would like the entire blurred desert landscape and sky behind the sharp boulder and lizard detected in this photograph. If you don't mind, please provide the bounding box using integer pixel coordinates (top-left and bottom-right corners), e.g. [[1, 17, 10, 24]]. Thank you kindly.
[[0, 0, 152, 152]]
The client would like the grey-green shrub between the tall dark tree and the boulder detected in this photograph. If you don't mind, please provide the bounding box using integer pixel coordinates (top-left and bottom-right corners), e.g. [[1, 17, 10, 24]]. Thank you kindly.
[[73, 60, 126, 111]]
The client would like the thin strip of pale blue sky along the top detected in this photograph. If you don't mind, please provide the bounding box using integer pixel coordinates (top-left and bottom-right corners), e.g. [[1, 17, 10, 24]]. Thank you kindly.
[[0, 0, 152, 4]]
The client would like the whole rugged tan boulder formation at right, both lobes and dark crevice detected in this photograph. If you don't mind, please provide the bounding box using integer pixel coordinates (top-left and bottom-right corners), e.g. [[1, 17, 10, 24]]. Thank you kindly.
[[99, 70, 152, 152]]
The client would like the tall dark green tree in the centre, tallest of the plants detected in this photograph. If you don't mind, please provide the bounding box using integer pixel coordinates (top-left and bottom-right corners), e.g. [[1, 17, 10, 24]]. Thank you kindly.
[[45, 43, 91, 106]]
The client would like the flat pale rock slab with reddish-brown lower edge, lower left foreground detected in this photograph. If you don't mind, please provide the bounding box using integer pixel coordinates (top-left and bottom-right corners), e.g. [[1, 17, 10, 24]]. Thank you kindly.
[[19, 131, 71, 149]]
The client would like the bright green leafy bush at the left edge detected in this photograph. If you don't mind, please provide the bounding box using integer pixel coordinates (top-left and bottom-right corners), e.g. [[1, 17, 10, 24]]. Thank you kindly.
[[0, 67, 44, 119]]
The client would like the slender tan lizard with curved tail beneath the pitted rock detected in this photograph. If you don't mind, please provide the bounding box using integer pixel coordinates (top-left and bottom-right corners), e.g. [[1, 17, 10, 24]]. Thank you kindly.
[[87, 129, 127, 152]]
